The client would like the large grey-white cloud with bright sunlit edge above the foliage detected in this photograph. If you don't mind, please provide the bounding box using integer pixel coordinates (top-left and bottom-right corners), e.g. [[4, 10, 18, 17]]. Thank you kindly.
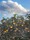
[[0, 0, 29, 18]]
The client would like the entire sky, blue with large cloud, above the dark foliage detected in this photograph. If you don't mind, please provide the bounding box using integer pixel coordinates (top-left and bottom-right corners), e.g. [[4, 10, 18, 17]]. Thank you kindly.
[[0, 0, 30, 20]]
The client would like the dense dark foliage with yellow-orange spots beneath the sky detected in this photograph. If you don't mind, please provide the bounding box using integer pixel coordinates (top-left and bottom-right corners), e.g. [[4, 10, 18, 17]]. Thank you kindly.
[[0, 14, 30, 40]]
